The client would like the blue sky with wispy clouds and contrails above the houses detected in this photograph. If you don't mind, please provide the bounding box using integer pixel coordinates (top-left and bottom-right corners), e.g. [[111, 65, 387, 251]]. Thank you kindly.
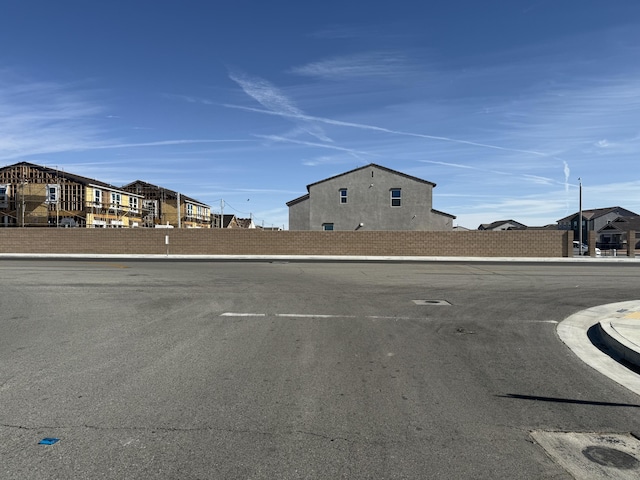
[[0, 0, 640, 228]]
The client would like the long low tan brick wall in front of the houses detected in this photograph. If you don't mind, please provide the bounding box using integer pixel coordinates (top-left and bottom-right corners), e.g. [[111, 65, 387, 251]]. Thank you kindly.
[[0, 228, 573, 257]]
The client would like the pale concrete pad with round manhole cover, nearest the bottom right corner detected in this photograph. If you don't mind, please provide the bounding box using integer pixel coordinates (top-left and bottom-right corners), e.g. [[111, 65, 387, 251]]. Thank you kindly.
[[531, 432, 640, 480]]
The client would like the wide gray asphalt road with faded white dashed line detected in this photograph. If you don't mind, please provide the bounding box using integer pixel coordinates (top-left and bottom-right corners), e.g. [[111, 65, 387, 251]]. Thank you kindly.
[[0, 260, 640, 480]]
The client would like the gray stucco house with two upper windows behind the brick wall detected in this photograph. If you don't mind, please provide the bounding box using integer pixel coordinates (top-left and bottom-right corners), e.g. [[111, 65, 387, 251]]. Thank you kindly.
[[287, 163, 456, 231]]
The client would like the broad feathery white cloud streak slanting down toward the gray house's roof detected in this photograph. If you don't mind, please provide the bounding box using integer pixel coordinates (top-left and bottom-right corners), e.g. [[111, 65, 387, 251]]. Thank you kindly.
[[229, 72, 332, 142]]
